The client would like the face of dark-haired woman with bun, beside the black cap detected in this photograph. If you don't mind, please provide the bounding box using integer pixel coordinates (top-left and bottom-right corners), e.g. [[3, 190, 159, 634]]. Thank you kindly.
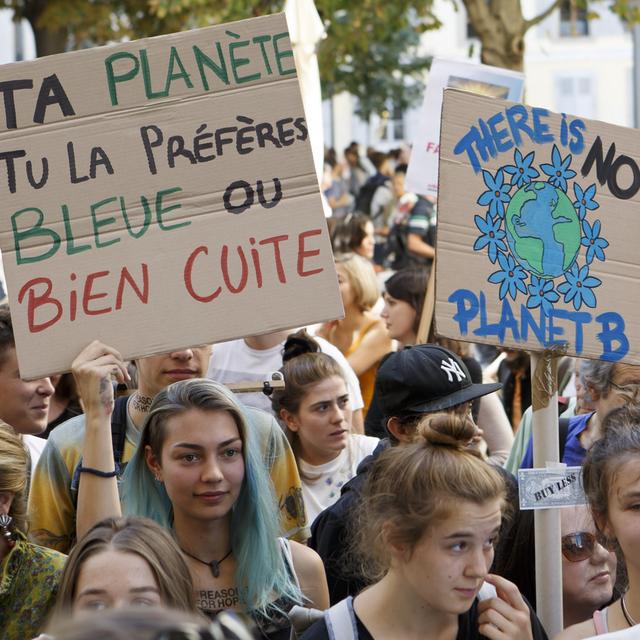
[[283, 376, 351, 465]]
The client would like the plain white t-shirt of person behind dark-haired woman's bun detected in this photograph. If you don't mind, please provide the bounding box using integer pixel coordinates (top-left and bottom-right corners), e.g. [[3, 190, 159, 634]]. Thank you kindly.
[[207, 336, 364, 413]]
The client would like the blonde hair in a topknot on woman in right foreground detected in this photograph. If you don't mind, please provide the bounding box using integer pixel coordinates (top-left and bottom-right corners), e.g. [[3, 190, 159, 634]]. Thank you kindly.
[[354, 413, 506, 582]]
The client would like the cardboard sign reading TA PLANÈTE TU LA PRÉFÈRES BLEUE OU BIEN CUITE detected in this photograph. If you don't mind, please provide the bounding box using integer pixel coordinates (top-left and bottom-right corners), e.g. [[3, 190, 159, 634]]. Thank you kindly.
[[0, 15, 342, 377]]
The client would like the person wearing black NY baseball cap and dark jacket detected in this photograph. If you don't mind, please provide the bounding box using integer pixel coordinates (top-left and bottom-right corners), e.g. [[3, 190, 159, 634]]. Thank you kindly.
[[309, 344, 501, 604]]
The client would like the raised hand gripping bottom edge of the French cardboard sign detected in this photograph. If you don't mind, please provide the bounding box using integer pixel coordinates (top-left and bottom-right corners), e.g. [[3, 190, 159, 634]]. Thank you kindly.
[[71, 340, 130, 415]]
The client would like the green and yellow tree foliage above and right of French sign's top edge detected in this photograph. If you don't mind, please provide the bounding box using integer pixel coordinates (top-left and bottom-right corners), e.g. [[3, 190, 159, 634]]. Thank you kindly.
[[0, 0, 440, 118]]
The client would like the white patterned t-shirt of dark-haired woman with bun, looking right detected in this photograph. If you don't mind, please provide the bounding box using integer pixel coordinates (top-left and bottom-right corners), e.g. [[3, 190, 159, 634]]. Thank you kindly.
[[298, 433, 380, 524]]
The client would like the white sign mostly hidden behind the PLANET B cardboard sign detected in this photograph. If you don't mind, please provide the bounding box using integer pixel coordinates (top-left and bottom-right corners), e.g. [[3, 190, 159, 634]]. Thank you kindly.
[[406, 58, 524, 196]]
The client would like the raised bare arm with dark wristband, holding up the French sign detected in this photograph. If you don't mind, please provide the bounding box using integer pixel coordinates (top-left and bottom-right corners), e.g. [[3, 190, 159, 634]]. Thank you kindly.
[[71, 340, 129, 540]]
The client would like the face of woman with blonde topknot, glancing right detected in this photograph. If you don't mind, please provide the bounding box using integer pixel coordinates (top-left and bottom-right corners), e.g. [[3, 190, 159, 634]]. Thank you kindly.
[[392, 499, 501, 616]]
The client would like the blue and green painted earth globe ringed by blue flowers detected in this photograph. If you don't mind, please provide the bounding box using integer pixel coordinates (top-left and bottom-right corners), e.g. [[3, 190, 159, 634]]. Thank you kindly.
[[505, 181, 581, 279]]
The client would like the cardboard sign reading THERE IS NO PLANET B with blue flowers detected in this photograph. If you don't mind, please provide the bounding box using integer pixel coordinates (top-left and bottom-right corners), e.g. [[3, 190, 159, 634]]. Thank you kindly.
[[436, 90, 640, 364]]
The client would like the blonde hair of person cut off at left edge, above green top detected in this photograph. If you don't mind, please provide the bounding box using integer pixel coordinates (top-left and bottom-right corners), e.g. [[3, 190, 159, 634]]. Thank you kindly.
[[0, 421, 29, 533]]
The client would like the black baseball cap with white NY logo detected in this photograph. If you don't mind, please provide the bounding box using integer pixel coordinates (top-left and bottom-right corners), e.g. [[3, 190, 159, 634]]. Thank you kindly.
[[376, 344, 502, 418]]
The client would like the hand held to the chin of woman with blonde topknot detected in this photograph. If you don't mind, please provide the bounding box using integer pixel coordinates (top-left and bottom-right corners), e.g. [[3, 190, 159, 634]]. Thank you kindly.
[[478, 574, 533, 640]]
